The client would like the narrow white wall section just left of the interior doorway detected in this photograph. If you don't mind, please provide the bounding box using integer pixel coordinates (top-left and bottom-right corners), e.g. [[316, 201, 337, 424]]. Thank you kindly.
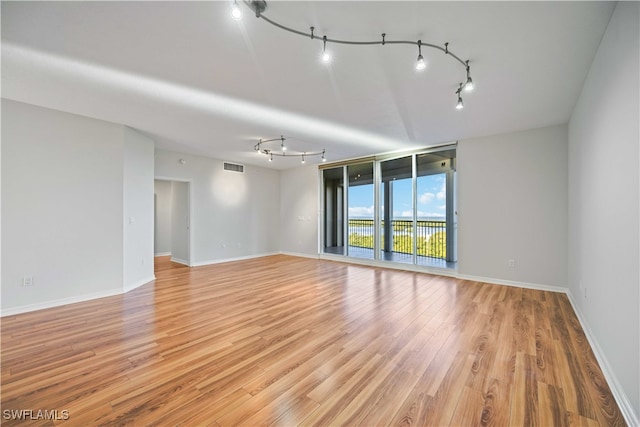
[[122, 127, 155, 290]]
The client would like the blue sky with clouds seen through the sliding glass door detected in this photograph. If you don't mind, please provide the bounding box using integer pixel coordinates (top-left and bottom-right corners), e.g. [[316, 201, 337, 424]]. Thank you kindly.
[[349, 174, 447, 219]]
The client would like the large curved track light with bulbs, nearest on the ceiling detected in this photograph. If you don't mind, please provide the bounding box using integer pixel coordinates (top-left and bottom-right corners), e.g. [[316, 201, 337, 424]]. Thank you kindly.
[[232, 0, 474, 109]]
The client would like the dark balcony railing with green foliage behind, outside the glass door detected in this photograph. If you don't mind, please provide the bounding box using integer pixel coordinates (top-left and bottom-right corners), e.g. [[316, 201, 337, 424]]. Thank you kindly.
[[349, 219, 447, 259]]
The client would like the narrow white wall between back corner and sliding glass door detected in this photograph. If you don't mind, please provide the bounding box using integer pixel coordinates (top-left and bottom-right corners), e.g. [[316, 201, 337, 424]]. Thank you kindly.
[[280, 166, 319, 257]]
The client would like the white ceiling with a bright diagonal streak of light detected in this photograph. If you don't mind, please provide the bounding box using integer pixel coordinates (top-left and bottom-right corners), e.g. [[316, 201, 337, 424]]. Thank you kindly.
[[1, 1, 615, 169]]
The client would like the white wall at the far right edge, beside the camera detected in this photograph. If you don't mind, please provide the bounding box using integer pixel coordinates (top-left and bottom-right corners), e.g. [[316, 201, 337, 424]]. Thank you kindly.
[[569, 2, 640, 423]]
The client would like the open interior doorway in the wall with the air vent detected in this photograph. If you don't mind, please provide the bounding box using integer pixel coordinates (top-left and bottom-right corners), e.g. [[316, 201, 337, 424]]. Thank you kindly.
[[154, 179, 192, 266]]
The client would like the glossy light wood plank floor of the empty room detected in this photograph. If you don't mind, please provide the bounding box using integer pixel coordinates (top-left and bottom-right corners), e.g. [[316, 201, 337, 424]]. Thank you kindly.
[[1, 256, 624, 426]]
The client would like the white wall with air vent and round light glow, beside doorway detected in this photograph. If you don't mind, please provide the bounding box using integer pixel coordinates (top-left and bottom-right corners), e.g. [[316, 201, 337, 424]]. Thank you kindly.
[[155, 150, 280, 265]]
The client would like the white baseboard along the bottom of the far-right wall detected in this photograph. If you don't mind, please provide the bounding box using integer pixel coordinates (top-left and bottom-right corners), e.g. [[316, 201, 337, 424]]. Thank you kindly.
[[566, 289, 640, 426]]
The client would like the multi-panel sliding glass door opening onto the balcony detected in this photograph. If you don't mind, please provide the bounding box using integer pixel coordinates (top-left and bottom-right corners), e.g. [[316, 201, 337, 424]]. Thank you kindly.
[[322, 146, 457, 268]]
